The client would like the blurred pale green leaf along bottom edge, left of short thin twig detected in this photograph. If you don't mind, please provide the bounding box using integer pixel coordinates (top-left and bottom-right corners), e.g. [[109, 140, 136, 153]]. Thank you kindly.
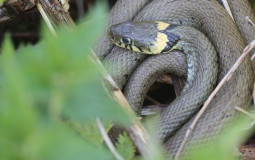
[[27, 124, 113, 160]]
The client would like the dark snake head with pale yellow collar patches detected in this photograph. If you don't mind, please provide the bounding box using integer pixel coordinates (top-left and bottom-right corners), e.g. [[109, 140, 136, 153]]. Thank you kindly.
[[108, 21, 179, 54]]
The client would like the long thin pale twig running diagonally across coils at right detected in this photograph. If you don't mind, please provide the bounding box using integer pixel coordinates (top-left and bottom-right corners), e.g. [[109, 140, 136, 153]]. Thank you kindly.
[[175, 40, 255, 160]]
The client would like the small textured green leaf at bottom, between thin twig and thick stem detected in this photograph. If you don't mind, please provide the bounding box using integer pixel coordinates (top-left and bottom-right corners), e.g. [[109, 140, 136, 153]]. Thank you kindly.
[[116, 132, 135, 160]]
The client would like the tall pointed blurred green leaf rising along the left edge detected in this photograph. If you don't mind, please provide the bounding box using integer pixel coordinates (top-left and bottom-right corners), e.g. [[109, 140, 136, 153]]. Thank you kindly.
[[0, 36, 37, 159]]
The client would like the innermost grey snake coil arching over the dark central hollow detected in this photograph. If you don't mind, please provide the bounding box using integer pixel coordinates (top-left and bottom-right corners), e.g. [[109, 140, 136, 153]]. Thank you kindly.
[[124, 51, 187, 108]]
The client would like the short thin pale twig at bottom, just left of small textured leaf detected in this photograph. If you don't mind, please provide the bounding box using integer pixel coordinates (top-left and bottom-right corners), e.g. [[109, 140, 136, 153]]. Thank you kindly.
[[96, 118, 124, 160]]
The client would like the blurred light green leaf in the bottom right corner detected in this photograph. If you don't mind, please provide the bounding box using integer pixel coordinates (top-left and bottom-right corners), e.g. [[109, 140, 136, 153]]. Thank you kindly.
[[189, 116, 254, 160]]
